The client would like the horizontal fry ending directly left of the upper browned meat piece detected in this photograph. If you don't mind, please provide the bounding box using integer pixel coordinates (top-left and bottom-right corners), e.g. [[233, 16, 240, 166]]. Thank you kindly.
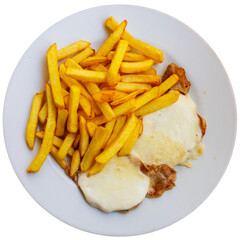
[[122, 75, 161, 86]]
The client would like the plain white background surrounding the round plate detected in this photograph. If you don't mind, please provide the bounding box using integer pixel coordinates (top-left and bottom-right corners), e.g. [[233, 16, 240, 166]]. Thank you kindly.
[[0, 0, 240, 240]]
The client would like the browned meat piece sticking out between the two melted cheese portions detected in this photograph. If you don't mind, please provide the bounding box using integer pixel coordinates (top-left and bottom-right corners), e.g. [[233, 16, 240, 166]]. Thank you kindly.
[[142, 164, 177, 198]]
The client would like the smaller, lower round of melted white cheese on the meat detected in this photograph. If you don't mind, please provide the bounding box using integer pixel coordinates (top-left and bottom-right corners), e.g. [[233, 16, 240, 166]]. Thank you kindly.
[[78, 156, 149, 212]]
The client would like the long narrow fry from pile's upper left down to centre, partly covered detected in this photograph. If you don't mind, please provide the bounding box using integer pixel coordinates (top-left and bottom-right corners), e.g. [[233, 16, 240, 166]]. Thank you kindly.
[[59, 63, 101, 115]]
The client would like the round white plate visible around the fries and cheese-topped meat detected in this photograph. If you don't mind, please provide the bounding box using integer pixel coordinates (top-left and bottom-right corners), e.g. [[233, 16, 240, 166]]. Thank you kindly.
[[4, 5, 236, 236]]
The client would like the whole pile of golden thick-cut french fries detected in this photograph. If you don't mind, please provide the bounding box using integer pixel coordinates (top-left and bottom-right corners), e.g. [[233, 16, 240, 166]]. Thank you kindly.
[[26, 17, 180, 177]]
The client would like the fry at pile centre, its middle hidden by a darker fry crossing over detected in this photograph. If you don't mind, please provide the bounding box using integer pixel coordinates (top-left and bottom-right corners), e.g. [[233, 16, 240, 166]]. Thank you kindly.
[[86, 83, 115, 121]]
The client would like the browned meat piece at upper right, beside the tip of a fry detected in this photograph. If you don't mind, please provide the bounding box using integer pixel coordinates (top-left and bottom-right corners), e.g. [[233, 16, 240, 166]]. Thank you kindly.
[[162, 63, 191, 95]]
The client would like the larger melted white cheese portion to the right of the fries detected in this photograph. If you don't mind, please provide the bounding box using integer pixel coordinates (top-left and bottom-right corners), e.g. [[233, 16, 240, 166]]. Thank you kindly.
[[131, 94, 203, 167]]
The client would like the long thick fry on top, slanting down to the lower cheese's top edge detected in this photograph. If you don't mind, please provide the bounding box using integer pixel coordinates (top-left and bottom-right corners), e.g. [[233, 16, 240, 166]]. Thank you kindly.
[[95, 113, 138, 163]]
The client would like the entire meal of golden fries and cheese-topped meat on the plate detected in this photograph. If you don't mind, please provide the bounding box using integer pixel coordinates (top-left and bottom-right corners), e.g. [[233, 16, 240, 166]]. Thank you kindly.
[[26, 17, 207, 212]]
